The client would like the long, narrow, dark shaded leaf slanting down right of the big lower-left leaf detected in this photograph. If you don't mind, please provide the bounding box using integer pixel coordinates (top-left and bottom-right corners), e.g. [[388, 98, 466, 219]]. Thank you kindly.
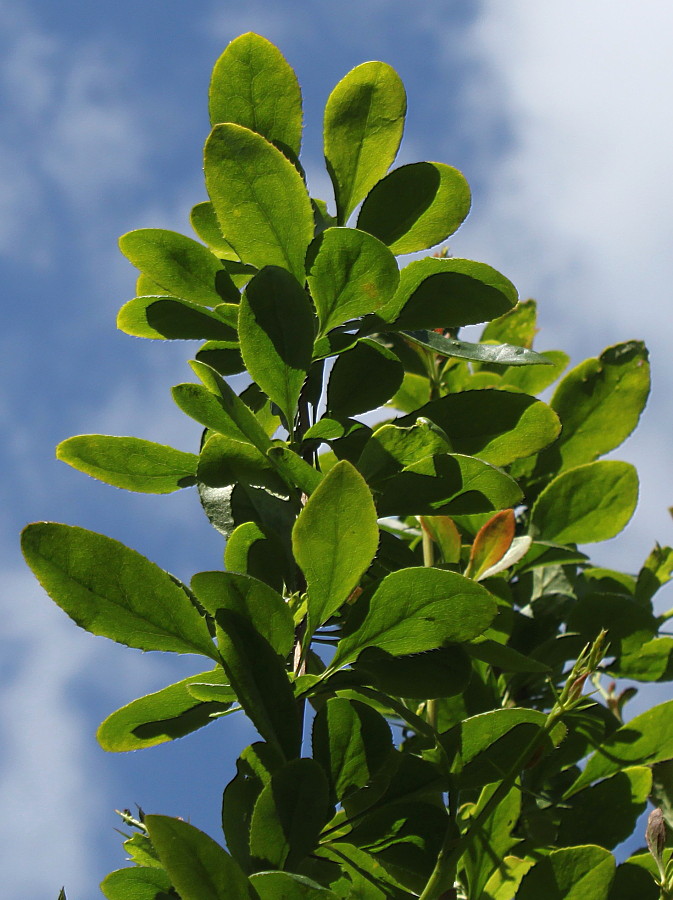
[[216, 609, 301, 759]]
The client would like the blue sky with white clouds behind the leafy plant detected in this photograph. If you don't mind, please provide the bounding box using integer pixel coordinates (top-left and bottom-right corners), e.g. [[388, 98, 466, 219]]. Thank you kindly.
[[0, 0, 673, 900]]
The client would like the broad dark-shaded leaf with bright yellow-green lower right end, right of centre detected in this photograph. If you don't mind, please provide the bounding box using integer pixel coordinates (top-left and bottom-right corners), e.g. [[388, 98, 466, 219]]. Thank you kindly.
[[395, 390, 561, 466]]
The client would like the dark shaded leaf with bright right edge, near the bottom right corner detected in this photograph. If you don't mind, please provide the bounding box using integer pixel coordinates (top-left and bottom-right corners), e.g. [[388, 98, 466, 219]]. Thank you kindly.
[[556, 766, 652, 850]]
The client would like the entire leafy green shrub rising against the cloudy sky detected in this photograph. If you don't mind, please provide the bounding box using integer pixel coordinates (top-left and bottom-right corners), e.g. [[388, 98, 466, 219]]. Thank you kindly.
[[23, 34, 673, 900]]
